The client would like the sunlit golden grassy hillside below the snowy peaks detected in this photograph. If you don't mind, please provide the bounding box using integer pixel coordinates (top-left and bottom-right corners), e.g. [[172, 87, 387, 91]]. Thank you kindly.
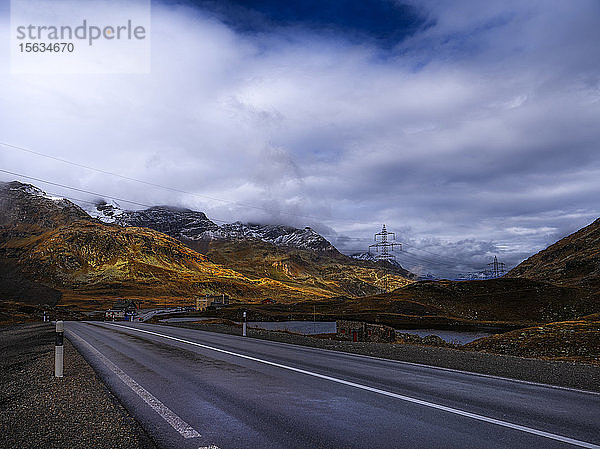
[[2, 221, 336, 306]]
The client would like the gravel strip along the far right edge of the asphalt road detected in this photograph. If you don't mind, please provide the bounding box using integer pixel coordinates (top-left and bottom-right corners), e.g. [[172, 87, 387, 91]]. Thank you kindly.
[[161, 323, 600, 392]]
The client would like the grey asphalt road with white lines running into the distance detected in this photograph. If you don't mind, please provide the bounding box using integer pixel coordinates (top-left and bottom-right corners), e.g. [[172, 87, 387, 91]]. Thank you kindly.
[[65, 322, 600, 449]]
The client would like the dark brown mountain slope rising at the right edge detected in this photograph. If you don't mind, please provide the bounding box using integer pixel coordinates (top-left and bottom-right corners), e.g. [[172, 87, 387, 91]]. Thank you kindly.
[[507, 219, 600, 292]]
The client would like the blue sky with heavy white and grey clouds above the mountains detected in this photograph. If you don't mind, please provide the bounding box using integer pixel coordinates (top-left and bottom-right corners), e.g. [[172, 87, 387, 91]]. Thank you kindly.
[[0, 0, 600, 277]]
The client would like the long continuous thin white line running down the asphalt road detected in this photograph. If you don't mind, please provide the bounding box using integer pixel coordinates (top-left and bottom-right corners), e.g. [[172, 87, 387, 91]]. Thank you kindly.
[[106, 323, 600, 449]]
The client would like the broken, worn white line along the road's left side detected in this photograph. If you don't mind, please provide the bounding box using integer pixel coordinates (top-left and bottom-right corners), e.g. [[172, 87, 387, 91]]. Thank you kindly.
[[68, 331, 200, 438]]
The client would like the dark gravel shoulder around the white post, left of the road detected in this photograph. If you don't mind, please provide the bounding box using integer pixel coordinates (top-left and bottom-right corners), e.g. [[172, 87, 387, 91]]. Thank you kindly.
[[0, 323, 156, 449]]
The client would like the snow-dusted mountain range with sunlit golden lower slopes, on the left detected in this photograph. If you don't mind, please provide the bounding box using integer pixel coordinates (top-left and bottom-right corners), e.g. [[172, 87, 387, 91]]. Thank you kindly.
[[0, 178, 411, 312]]
